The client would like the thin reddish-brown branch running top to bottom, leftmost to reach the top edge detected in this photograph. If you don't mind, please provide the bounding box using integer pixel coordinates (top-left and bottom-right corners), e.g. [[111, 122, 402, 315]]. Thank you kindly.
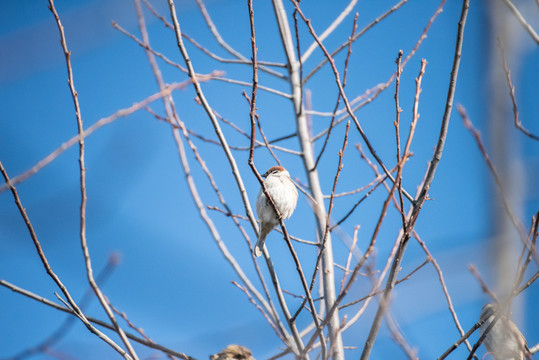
[[49, 0, 138, 360]]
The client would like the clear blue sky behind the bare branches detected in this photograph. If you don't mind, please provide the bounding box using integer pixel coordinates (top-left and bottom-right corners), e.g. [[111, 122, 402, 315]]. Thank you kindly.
[[0, 0, 539, 359]]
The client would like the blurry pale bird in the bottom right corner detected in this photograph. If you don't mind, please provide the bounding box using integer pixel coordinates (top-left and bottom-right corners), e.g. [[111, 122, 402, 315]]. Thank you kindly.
[[479, 304, 531, 360]]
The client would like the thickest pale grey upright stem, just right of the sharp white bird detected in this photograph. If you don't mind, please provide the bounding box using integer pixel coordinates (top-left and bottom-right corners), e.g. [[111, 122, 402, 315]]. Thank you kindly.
[[273, 0, 344, 360]]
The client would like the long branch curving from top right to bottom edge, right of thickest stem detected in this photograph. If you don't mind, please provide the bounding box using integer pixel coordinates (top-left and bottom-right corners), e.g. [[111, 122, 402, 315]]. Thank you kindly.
[[361, 0, 470, 360]]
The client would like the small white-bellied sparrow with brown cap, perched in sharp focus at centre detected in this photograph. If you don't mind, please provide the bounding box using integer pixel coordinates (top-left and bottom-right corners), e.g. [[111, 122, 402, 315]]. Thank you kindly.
[[254, 166, 298, 257]]
